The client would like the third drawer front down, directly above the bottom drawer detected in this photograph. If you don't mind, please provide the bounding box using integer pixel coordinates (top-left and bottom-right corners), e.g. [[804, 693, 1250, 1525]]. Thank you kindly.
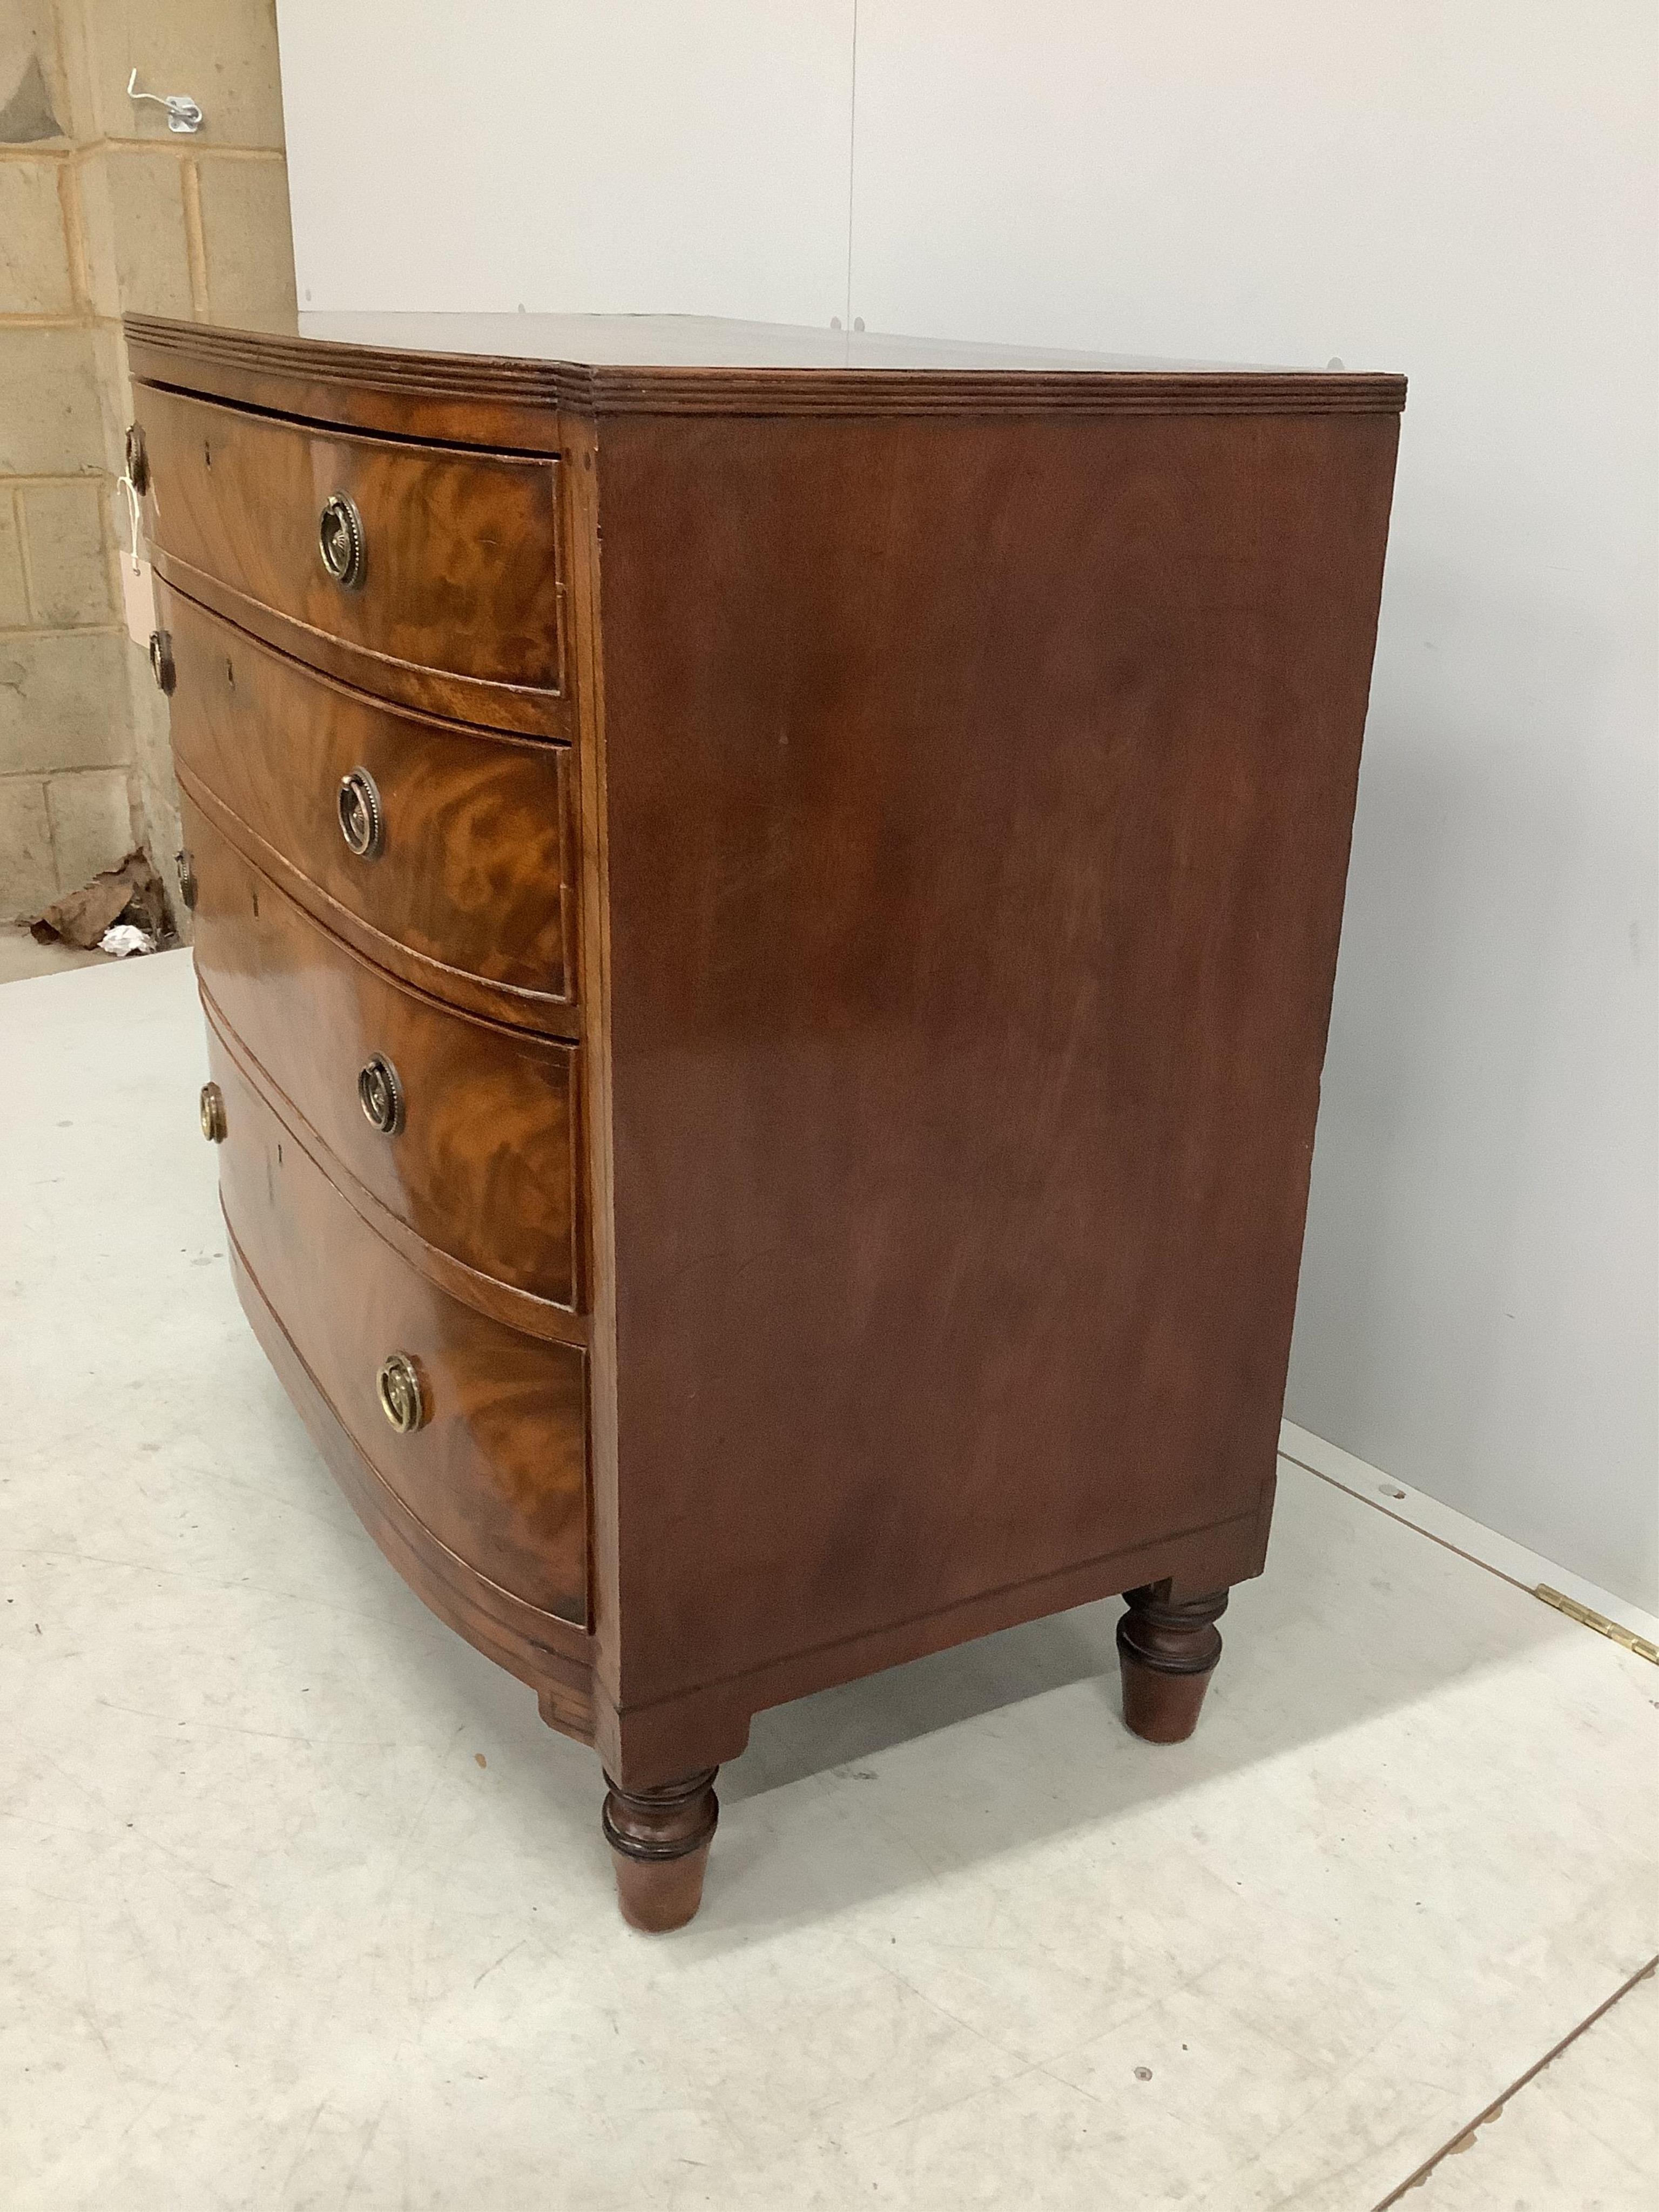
[[184, 799, 577, 1310]]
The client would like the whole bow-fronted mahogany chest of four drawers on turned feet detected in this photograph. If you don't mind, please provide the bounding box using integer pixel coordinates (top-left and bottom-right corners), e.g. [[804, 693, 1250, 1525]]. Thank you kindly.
[[129, 316, 1405, 1929]]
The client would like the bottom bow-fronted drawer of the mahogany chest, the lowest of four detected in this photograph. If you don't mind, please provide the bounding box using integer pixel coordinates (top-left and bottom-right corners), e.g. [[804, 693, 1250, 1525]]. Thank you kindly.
[[208, 1027, 589, 1621]]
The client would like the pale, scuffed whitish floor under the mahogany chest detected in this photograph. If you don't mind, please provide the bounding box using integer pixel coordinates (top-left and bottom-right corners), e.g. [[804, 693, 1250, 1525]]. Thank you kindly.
[[0, 953, 1659, 2212]]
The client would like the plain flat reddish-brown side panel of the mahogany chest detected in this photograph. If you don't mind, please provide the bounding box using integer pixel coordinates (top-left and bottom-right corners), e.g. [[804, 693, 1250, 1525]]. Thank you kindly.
[[599, 414, 1396, 1703]]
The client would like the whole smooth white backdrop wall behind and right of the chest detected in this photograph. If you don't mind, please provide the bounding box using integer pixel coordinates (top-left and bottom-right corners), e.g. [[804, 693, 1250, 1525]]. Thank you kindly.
[[279, 0, 1659, 1604]]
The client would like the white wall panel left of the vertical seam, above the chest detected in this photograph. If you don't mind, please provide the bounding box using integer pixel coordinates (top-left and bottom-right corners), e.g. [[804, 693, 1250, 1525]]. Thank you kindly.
[[276, 0, 852, 323]]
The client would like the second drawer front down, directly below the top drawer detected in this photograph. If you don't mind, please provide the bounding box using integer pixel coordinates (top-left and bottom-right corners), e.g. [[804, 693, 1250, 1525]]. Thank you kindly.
[[157, 584, 575, 1024]]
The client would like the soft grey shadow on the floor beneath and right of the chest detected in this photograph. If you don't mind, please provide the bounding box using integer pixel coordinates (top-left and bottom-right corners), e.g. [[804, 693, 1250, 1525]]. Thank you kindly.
[[694, 1462, 1584, 1933]]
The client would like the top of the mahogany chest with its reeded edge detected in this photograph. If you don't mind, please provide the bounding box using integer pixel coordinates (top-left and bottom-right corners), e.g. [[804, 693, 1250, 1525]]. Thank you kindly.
[[126, 314, 1405, 416]]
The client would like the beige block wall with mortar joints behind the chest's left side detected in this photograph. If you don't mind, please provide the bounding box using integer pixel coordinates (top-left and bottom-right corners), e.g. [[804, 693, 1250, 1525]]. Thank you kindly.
[[0, 0, 294, 922]]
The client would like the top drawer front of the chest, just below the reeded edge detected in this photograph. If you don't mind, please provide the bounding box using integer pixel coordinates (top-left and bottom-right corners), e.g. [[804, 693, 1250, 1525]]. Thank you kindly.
[[137, 387, 559, 730]]
